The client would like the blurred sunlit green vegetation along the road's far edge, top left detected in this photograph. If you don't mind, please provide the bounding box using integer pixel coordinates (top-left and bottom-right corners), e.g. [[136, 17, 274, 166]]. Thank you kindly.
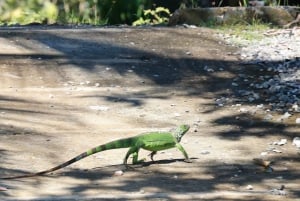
[[0, 0, 151, 25]]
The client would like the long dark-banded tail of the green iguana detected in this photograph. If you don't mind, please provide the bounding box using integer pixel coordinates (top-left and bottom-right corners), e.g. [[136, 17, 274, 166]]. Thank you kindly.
[[0, 138, 135, 179]]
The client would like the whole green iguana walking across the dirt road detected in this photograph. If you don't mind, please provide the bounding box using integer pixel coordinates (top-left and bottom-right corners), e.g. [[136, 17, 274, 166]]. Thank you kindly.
[[0, 125, 190, 179]]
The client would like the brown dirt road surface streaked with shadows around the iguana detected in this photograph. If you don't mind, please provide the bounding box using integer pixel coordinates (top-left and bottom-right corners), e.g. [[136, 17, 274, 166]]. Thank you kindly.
[[0, 27, 300, 200]]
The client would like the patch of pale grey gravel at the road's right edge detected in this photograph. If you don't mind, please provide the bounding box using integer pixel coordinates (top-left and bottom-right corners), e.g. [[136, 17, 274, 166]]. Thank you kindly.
[[219, 27, 300, 116]]
